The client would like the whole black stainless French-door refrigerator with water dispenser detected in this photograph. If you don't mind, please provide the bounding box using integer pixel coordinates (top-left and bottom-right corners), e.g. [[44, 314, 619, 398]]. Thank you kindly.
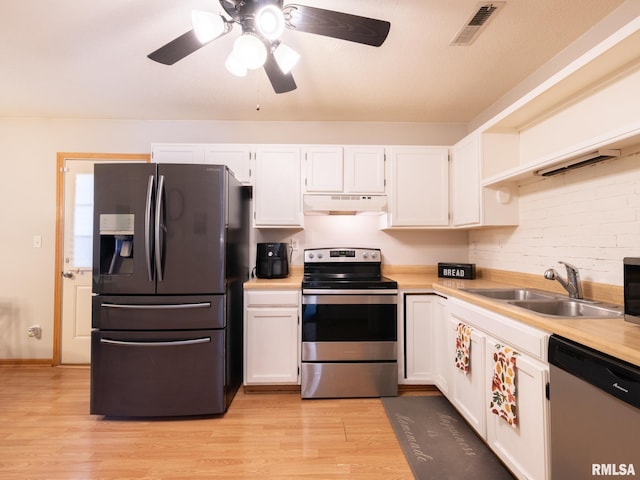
[[90, 163, 250, 417]]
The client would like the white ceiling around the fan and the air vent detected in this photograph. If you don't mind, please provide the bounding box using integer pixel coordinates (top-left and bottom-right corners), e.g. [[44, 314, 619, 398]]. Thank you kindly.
[[0, 0, 623, 123]]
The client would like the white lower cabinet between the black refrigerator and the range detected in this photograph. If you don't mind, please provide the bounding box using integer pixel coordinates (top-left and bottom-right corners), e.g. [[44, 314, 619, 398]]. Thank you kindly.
[[244, 290, 300, 385]]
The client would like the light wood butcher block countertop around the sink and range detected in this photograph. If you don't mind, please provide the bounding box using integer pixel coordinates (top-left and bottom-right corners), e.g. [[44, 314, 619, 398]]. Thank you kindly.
[[245, 266, 640, 366]]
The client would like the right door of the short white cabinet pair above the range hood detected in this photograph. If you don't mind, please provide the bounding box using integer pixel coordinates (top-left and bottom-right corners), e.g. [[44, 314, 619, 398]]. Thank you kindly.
[[344, 147, 385, 193]]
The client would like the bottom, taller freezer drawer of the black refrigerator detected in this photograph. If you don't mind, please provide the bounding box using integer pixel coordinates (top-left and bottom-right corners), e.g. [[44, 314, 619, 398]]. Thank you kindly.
[[90, 330, 230, 417]]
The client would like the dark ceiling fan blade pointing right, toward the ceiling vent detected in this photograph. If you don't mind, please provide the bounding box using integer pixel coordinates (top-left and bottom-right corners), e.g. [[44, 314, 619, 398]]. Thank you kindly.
[[283, 4, 391, 47]]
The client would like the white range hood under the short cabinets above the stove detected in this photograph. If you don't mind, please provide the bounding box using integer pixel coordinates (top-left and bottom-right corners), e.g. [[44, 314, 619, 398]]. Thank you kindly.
[[303, 194, 387, 215]]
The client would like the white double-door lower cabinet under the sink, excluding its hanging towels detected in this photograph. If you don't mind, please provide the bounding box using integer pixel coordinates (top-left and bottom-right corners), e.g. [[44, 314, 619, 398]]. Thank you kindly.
[[445, 298, 550, 480]]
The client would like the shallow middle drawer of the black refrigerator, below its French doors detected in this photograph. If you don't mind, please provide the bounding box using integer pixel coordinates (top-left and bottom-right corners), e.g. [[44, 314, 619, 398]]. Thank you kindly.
[[92, 295, 226, 330]]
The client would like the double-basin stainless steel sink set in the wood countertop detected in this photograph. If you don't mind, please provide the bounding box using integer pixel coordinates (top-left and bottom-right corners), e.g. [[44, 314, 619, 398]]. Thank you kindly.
[[462, 288, 624, 319]]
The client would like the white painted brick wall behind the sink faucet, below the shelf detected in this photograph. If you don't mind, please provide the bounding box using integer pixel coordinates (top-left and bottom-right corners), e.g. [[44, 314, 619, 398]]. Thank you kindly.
[[469, 154, 640, 285]]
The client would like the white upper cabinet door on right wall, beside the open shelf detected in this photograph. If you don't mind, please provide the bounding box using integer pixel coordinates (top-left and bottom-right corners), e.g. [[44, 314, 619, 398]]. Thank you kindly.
[[451, 134, 481, 226]]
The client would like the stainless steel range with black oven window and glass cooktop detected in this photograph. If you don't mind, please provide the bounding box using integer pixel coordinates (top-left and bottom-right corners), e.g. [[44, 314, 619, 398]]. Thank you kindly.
[[301, 248, 398, 398]]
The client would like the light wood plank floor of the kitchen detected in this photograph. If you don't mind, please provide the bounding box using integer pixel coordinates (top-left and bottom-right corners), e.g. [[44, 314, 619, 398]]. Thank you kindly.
[[0, 367, 436, 480]]
